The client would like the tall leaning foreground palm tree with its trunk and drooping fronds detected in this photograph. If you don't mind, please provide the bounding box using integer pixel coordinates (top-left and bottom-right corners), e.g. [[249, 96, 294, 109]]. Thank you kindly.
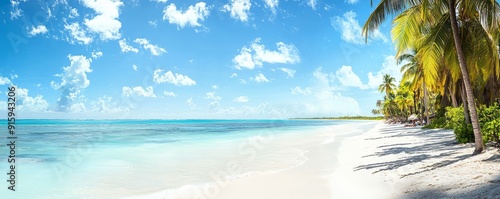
[[363, 0, 500, 154]]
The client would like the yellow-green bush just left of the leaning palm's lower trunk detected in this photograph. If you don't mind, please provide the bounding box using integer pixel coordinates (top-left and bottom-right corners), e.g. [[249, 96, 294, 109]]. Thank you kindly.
[[445, 107, 474, 143]]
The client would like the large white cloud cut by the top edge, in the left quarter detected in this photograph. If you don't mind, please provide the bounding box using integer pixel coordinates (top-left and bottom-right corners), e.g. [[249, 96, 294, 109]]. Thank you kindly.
[[83, 0, 123, 41]]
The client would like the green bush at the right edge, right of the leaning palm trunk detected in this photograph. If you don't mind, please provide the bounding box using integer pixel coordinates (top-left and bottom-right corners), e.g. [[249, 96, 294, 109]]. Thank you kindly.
[[479, 103, 500, 143]]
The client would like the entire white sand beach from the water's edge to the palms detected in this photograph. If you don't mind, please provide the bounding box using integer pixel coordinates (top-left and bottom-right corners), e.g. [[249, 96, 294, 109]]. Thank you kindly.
[[161, 122, 500, 199]]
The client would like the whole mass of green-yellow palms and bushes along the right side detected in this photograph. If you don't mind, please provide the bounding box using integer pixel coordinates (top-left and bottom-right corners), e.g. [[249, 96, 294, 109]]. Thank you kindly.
[[363, 0, 500, 154]]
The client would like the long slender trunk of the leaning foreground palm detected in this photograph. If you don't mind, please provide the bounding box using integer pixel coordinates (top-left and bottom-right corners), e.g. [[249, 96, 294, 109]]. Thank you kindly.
[[448, 0, 484, 155]]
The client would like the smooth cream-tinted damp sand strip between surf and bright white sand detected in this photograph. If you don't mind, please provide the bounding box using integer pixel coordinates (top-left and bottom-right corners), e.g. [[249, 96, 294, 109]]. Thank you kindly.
[[207, 121, 377, 199]]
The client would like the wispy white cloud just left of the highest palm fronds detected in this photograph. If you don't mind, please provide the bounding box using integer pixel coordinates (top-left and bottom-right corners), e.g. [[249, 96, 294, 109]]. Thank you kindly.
[[331, 11, 388, 44]]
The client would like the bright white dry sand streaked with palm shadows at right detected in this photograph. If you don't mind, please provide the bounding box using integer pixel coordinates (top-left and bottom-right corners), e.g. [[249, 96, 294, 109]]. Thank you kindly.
[[331, 124, 500, 198]]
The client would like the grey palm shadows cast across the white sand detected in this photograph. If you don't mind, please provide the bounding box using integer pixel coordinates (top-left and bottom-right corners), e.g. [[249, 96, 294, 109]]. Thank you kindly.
[[354, 126, 500, 199]]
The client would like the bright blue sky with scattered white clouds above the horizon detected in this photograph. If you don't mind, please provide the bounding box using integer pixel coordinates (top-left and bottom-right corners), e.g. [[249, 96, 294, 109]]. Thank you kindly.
[[0, 0, 401, 119]]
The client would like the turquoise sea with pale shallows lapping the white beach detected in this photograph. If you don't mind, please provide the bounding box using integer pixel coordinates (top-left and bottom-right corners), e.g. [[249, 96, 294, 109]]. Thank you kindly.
[[0, 119, 366, 199]]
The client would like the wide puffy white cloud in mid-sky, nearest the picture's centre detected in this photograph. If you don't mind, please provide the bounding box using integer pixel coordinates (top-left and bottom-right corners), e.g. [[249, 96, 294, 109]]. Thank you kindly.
[[233, 38, 300, 70]]
